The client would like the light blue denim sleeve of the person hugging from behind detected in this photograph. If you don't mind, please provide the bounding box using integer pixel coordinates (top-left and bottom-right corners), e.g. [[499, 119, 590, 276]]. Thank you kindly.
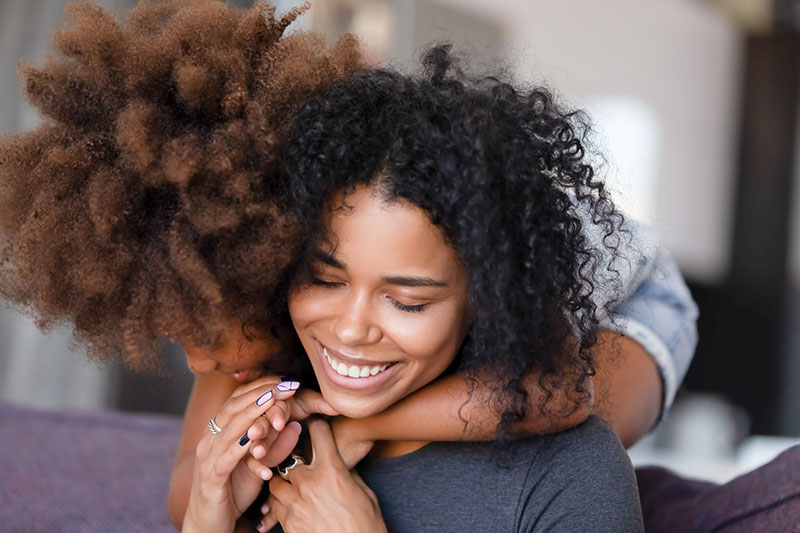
[[598, 221, 699, 420]]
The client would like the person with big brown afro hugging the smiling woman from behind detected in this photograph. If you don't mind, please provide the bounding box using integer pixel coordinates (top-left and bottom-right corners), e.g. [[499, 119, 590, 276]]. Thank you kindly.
[[0, 0, 696, 525]]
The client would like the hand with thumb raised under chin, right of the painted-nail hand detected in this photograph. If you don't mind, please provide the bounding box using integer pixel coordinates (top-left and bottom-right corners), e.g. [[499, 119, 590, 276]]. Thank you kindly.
[[258, 418, 386, 533]]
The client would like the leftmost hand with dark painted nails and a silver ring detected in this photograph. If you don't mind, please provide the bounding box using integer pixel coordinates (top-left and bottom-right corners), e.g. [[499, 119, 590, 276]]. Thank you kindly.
[[183, 378, 300, 531]]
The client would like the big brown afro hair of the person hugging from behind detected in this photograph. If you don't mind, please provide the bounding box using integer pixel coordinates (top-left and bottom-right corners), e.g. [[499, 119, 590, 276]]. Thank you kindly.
[[0, 0, 362, 370]]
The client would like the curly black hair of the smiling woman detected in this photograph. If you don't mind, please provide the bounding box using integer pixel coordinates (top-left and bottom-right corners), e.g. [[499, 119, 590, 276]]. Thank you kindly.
[[283, 45, 623, 441]]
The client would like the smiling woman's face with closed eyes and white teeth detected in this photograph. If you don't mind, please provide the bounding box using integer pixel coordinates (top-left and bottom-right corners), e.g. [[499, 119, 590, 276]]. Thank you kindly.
[[289, 186, 468, 418]]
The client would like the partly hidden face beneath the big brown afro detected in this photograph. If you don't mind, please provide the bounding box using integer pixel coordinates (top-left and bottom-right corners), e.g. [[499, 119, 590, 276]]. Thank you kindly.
[[183, 322, 280, 383]]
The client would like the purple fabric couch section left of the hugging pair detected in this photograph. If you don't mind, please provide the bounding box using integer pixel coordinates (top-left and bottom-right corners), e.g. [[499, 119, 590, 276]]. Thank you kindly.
[[0, 406, 180, 532]]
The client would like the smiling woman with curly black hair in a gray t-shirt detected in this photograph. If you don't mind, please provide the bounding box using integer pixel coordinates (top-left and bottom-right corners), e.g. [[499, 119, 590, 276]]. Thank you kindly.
[[186, 47, 642, 531]]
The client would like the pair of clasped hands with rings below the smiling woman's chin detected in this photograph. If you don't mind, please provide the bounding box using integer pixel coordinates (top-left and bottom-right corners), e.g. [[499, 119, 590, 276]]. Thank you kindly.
[[183, 377, 382, 532]]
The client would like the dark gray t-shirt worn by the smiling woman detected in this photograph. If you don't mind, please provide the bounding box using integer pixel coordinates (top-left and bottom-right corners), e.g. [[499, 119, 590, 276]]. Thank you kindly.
[[358, 416, 643, 533]]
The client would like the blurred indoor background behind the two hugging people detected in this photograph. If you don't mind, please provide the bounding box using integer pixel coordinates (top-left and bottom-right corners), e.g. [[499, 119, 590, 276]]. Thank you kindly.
[[0, 0, 800, 480]]
